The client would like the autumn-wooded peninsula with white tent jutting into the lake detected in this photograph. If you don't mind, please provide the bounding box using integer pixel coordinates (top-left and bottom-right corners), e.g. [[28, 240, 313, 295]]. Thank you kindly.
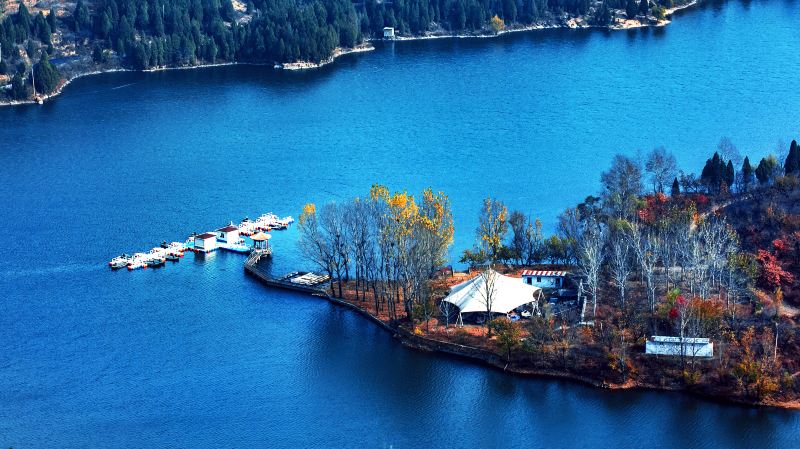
[[298, 139, 800, 409]]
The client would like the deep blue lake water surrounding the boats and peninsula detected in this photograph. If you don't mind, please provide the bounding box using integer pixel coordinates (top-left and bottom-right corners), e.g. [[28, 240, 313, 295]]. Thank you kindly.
[[0, 0, 800, 448]]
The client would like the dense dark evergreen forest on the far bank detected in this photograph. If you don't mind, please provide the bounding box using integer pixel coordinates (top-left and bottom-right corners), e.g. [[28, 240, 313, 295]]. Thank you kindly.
[[0, 0, 688, 98]]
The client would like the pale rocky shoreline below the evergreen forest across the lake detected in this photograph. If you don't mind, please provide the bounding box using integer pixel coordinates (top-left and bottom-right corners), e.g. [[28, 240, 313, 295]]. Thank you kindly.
[[0, 0, 700, 107]]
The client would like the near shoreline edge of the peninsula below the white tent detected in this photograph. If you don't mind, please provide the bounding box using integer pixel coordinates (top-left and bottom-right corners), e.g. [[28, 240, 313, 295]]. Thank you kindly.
[[312, 284, 800, 411]]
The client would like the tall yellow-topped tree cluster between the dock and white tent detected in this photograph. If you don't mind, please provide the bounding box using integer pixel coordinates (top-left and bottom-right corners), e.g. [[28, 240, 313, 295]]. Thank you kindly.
[[298, 185, 454, 320]]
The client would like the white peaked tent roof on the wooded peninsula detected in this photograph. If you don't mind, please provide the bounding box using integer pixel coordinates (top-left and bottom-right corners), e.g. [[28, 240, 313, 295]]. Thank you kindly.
[[444, 270, 542, 313]]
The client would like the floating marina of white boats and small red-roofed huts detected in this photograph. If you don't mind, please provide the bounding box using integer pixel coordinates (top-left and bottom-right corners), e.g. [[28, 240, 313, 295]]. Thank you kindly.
[[108, 212, 294, 271]]
